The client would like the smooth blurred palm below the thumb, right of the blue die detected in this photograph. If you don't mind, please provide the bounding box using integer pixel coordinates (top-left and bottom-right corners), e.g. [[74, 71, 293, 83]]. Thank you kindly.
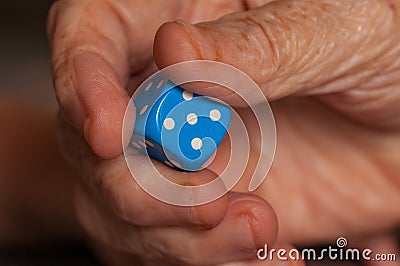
[[225, 97, 400, 244]]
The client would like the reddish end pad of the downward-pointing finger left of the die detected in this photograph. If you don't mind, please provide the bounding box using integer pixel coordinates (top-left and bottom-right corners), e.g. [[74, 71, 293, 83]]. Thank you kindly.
[[74, 53, 129, 159]]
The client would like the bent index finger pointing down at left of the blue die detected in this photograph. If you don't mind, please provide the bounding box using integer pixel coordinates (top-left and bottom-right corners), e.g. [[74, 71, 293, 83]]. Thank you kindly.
[[48, 1, 129, 157]]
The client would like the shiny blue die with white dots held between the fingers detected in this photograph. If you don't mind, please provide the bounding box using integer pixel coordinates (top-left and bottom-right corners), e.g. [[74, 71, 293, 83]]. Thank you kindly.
[[130, 75, 231, 171]]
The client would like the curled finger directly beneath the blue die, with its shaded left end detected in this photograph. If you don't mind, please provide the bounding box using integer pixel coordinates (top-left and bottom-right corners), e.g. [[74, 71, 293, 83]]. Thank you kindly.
[[59, 117, 227, 228]]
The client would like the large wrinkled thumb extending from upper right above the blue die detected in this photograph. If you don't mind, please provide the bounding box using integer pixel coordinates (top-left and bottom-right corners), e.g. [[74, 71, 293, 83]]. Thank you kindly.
[[154, 0, 399, 104]]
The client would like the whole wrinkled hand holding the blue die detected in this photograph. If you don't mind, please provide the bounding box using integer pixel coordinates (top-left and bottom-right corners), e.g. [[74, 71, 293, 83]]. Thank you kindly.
[[48, 0, 400, 265]]
